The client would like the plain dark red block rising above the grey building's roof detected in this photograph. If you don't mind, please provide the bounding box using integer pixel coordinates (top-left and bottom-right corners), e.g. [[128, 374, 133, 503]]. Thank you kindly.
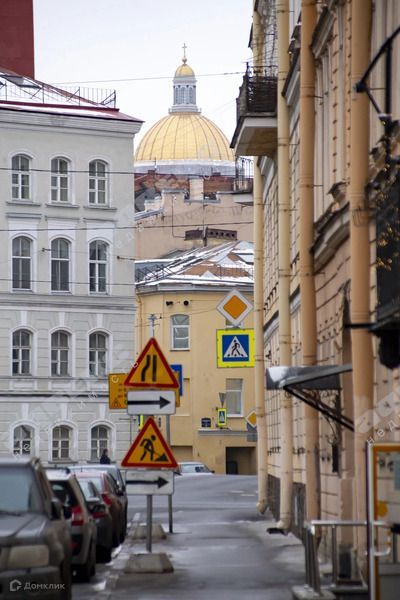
[[0, 0, 35, 78]]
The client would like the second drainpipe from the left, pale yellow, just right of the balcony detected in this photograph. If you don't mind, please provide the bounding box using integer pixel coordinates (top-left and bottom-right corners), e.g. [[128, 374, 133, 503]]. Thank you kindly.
[[276, 0, 293, 530]]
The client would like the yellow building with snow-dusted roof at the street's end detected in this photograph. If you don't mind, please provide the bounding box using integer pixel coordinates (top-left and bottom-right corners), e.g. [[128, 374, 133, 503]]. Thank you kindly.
[[136, 242, 256, 474]]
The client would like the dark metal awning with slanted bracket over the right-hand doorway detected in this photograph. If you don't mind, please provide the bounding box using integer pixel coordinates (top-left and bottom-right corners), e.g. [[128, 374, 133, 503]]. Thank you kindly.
[[266, 364, 354, 431]]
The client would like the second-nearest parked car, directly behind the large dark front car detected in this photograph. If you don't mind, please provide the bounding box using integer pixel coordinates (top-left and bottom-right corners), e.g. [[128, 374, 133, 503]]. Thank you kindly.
[[46, 468, 97, 581]]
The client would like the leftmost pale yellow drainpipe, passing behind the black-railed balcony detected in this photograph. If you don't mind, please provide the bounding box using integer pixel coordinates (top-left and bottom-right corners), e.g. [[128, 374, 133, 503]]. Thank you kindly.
[[253, 4, 268, 514]]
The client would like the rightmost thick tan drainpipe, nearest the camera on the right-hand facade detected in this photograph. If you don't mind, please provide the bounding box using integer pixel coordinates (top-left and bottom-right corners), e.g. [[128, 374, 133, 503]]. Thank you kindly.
[[348, 0, 374, 565]]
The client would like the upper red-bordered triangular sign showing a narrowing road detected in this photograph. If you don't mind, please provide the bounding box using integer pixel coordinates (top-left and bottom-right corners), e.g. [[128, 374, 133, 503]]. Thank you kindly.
[[124, 338, 179, 390]]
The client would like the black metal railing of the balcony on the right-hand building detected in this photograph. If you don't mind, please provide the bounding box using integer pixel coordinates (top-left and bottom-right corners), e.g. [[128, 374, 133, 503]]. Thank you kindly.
[[236, 66, 277, 121]]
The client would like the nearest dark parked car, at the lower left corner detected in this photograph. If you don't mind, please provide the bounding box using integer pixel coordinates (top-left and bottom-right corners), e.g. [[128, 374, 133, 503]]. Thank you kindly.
[[0, 458, 71, 600]]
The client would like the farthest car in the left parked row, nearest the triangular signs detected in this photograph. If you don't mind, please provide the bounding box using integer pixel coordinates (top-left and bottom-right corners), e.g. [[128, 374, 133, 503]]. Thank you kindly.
[[75, 470, 125, 548]]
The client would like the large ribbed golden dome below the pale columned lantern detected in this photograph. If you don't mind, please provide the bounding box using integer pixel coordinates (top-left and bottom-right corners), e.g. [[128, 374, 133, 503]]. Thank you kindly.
[[135, 113, 235, 161]]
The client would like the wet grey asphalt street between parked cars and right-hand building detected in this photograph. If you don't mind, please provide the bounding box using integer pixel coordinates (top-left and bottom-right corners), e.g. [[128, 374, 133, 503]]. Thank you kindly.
[[73, 475, 304, 600]]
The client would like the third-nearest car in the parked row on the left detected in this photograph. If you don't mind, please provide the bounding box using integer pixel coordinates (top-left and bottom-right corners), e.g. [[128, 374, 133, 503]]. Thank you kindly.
[[78, 477, 113, 562]]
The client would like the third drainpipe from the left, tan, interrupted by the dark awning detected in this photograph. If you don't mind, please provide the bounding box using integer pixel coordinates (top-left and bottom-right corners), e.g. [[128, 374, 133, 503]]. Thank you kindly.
[[299, 0, 319, 520]]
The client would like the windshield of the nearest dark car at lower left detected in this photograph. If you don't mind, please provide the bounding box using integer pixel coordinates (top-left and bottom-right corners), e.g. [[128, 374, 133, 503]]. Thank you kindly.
[[0, 466, 43, 513]]
